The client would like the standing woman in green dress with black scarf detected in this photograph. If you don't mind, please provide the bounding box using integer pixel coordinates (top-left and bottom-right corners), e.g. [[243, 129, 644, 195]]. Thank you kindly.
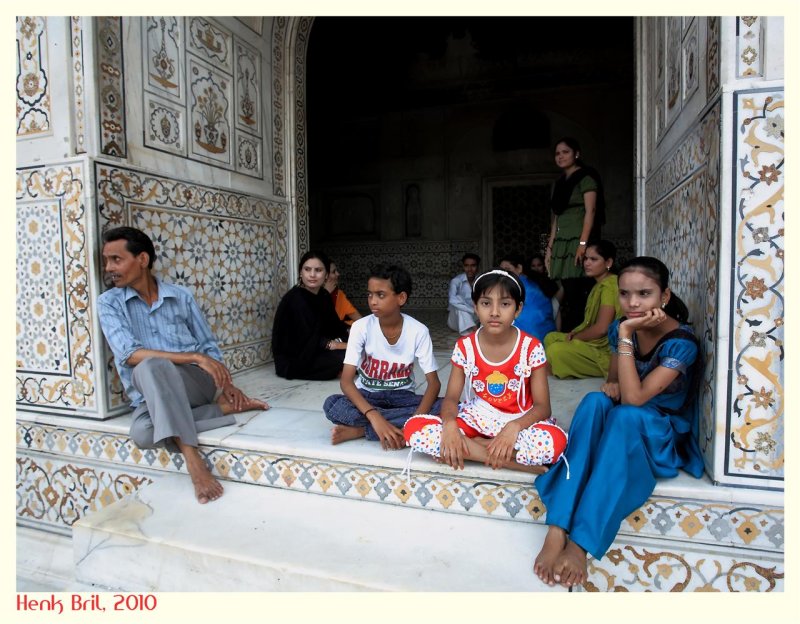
[[545, 137, 605, 279]]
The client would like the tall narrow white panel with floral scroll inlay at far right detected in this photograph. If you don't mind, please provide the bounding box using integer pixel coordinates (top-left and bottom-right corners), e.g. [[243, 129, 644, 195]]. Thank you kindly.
[[725, 89, 785, 479]]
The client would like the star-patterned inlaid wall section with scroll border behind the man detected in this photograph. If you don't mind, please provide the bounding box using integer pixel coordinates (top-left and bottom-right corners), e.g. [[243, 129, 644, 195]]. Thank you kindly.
[[95, 163, 288, 404]]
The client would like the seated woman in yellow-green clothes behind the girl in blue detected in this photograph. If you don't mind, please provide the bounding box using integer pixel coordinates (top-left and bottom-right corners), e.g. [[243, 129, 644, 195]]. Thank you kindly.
[[544, 240, 621, 378]]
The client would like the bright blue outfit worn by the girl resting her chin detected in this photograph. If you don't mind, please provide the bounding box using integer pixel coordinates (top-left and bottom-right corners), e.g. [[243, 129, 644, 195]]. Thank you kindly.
[[535, 319, 703, 559]]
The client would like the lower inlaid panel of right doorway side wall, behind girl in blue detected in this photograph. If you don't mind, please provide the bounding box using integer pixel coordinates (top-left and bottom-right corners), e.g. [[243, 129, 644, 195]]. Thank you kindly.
[[643, 104, 720, 469]]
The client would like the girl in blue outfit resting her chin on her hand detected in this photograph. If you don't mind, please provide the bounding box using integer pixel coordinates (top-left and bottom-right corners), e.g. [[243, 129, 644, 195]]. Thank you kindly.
[[534, 257, 703, 587]]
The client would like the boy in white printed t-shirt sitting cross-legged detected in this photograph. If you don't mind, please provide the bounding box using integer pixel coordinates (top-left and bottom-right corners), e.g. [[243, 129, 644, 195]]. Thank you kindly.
[[322, 264, 441, 450]]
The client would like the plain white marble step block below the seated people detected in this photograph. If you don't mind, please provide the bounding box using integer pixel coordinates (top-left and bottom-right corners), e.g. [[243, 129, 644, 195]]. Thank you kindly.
[[73, 475, 565, 591]]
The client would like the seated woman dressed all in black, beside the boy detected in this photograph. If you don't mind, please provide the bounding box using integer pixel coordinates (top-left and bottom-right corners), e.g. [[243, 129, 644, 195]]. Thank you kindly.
[[272, 251, 348, 380]]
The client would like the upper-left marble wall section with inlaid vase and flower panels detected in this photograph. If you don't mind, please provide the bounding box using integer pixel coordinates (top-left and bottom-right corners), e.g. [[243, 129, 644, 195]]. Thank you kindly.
[[139, 16, 263, 178]]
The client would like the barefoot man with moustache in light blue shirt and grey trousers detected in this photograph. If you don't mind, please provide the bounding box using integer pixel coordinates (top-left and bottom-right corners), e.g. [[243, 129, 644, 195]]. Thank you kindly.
[[98, 227, 269, 503]]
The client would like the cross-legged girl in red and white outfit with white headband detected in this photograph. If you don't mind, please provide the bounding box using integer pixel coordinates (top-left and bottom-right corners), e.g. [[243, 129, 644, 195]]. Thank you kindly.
[[403, 269, 567, 473]]
